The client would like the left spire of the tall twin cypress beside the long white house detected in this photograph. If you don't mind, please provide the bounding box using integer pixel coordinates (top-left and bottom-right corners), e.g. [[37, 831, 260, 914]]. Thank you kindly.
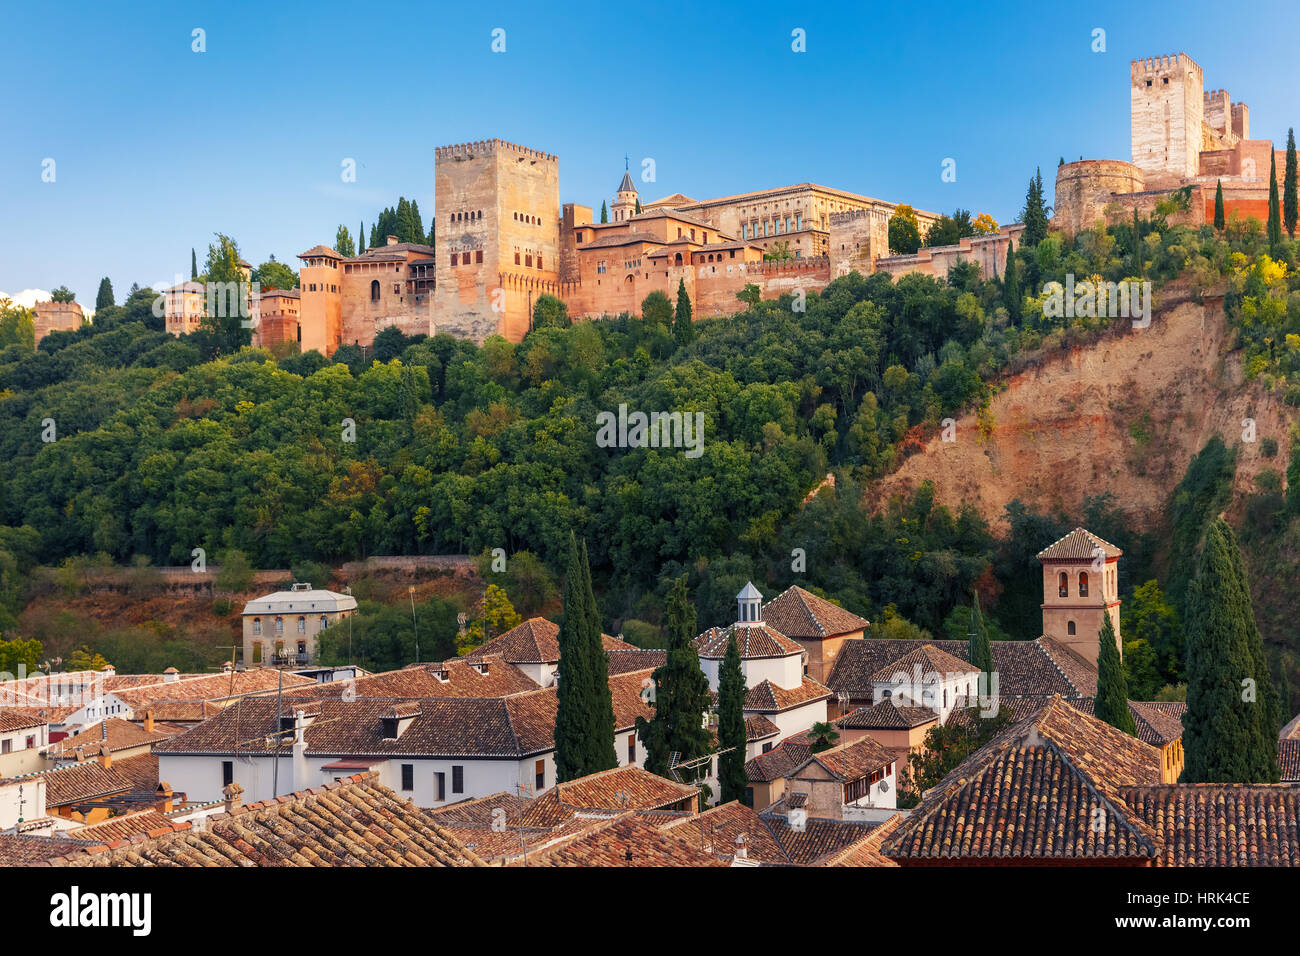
[[555, 532, 594, 783]]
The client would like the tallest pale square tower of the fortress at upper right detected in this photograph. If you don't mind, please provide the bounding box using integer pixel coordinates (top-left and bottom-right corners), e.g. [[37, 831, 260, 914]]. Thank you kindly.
[[1128, 53, 1205, 187]]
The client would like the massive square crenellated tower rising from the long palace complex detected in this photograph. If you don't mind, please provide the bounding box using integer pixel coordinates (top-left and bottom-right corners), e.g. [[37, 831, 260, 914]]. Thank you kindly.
[[433, 139, 560, 342]]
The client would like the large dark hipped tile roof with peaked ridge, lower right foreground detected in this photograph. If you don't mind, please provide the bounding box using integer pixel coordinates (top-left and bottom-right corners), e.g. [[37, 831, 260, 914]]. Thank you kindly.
[[883, 697, 1161, 861]]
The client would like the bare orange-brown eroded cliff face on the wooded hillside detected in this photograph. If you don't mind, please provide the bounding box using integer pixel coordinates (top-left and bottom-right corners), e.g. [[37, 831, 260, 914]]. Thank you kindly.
[[867, 298, 1294, 533]]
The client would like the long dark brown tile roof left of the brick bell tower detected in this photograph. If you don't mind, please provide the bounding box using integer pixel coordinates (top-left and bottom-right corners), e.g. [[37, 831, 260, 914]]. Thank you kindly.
[[827, 637, 1097, 698]]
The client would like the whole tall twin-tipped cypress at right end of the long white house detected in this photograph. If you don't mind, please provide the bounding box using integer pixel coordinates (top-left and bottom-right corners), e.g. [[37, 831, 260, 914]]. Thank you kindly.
[[555, 532, 618, 783]]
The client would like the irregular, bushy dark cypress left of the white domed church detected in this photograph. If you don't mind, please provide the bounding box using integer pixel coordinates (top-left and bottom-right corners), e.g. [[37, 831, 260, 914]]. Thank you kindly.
[[637, 575, 710, 777]]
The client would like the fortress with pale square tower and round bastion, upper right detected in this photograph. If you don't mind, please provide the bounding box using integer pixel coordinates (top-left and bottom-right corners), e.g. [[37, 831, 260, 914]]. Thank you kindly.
[[1053, 53, 1286, 234]]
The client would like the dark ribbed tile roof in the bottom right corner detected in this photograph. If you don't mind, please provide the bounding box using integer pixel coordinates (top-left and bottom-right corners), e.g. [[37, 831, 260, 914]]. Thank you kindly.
[[1119, 783, 1300, 866]]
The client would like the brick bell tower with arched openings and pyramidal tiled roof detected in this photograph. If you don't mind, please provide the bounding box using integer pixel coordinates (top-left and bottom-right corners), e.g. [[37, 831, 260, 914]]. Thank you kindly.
[[1039, 528, 1125, 662]]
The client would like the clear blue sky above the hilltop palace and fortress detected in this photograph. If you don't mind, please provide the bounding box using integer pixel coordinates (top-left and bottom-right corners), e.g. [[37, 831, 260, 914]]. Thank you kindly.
[[0, 0, 1300, 306]]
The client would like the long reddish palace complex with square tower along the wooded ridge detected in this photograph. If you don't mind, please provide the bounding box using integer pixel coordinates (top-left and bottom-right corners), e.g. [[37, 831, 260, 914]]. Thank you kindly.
[[166, 139, 1022, 355]]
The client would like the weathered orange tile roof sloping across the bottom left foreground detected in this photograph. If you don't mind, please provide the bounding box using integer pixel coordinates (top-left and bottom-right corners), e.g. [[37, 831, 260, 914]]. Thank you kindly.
[[44, 775, 485, 866]]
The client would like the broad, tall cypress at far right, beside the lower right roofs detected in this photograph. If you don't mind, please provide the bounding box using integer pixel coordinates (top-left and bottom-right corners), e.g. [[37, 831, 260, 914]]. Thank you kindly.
[[1180, 518, 1281, 783]]
